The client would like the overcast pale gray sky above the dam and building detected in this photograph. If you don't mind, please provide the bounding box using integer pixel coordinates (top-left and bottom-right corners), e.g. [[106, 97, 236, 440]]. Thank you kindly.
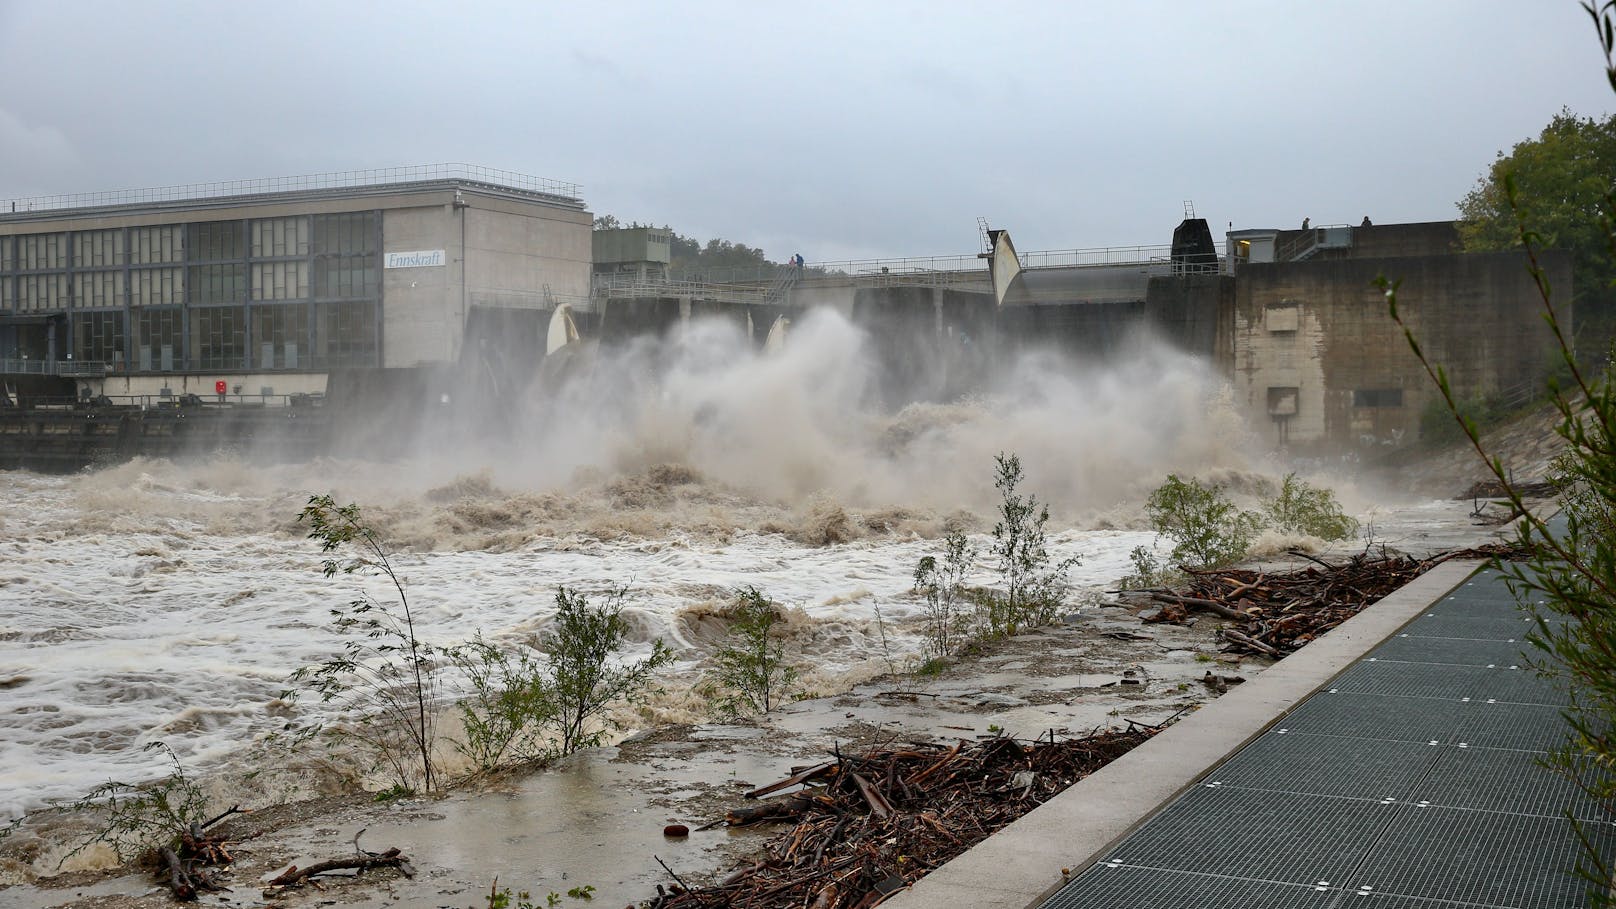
[[0, 0, 1616, 260]]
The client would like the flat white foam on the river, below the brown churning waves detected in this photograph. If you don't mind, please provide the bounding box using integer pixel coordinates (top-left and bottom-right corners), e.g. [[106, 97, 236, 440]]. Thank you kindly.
[[0, 464, 1147, 815]]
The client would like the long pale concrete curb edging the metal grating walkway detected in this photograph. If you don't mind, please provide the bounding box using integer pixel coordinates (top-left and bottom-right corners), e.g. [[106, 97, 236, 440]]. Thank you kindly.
[[881, 561, 1480, 909]]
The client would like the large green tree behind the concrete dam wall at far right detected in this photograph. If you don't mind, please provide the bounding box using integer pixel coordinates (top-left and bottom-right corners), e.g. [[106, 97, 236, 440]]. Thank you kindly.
[[1459, 108, 1616, 354]]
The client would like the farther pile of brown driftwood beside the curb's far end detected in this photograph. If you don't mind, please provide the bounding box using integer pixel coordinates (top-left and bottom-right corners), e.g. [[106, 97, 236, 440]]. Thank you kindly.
[[1143, 545, 1517, 657]]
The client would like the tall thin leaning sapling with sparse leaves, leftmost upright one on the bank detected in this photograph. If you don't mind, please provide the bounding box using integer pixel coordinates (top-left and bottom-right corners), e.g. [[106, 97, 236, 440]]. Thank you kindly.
[[283, 495, 440, 791]]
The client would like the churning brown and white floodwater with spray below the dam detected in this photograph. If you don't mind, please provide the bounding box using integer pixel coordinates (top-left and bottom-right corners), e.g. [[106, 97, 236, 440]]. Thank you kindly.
[[0, 310, 1499, 899]]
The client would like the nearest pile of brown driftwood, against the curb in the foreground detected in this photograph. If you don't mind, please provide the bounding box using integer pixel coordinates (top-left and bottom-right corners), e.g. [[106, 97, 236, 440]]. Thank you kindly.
[[650, 723, 1159, 909]]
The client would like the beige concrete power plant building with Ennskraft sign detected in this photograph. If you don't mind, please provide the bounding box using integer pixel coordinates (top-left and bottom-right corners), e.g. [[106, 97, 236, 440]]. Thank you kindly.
[[0, 165, 591, 401]]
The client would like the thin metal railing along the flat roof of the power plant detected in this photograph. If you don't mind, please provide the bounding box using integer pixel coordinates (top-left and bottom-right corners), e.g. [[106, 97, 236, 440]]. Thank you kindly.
[[0, 163, 583, 218]]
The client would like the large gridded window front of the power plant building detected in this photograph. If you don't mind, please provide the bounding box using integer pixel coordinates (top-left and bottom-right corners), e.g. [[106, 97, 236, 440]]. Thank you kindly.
[[0, 210, 381, 372]]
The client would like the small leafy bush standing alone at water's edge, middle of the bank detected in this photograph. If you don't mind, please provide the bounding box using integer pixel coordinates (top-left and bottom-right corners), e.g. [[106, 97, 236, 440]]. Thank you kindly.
[[705, 587, 798, 717]]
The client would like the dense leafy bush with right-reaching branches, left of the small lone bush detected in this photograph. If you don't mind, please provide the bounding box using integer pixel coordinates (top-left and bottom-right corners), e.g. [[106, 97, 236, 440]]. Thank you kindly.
[[541, 587, 674, 755]]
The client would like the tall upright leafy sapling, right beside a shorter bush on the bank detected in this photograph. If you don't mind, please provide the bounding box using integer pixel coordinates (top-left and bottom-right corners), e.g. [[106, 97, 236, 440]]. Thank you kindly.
[[976, 451, 1078, 634]]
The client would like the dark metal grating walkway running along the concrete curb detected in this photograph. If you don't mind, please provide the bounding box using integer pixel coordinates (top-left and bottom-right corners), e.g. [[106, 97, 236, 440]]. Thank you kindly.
[[1042, 571, 1616, 909]]
